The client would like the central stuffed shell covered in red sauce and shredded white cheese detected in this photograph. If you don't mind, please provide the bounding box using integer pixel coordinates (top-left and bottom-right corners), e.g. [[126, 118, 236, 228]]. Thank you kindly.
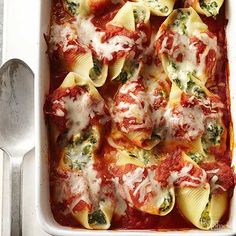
[[111, 76, 158, 149]]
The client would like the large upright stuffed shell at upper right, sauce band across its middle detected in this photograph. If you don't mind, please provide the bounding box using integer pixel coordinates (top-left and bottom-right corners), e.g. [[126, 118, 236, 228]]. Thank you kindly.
[[156, 8, 218, 90]]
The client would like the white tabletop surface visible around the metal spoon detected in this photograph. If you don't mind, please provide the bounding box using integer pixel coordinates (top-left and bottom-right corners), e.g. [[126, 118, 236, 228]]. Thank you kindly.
[[0, 0, 50, 236]]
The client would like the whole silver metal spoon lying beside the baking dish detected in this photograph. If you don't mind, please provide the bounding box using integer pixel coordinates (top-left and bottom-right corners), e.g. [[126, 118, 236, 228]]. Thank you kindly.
[[0, 59, 34, 236]]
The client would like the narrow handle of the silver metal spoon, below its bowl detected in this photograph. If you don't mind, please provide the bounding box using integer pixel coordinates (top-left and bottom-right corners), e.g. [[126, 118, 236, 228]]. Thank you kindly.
[[10, 157, 23, 236]]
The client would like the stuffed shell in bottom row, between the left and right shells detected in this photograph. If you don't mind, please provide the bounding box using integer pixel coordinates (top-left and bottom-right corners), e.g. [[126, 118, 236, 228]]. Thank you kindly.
[[105, 143, 175, 216]]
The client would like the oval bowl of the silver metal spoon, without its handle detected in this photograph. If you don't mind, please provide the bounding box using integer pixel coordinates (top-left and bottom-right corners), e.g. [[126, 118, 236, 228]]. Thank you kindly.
[[0, 59, 34, 156]]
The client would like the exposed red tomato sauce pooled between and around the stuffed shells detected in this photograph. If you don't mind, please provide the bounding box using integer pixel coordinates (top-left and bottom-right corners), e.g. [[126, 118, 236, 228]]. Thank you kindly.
[[46, 0, 232, 231]]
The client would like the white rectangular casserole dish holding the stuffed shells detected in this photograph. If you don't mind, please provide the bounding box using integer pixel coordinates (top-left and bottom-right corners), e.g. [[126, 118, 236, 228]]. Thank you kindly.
[[35, 0, 236, 236]]
